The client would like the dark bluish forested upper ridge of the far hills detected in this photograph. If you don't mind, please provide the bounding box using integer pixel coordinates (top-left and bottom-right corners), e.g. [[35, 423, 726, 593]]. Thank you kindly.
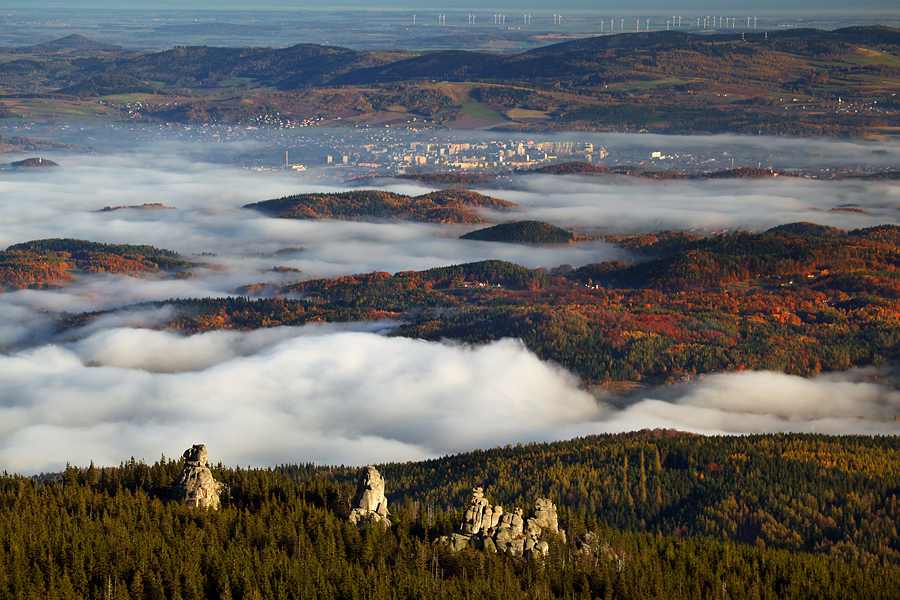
[[89, 27, 900, 89]]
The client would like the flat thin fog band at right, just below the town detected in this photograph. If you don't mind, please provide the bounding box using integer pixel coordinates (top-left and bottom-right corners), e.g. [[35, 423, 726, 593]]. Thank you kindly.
[[506, 175, 900, 233]]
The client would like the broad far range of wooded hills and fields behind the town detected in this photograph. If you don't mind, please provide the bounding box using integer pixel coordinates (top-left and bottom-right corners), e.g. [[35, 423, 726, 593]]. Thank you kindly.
[[0, 26, 900, 137]]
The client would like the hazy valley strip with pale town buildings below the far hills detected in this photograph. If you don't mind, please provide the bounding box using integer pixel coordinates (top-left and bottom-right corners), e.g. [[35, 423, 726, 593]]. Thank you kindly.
[[0, 120, 897, 178]]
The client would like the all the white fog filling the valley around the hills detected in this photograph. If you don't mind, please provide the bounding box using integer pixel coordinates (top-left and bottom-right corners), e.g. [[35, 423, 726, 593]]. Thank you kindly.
[[0, 129, 900, 473]]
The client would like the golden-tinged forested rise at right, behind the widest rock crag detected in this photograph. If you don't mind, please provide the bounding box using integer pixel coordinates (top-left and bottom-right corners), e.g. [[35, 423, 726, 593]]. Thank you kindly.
[[378, 430, 900, 565]]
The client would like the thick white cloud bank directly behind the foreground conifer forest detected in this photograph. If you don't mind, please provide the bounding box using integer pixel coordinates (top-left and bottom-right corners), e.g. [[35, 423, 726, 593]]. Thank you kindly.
[[0, 324, 900, 473]]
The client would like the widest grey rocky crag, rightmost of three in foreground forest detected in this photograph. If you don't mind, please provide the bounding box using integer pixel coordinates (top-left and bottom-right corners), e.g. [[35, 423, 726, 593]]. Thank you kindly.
[[441, 487, 565, 556]]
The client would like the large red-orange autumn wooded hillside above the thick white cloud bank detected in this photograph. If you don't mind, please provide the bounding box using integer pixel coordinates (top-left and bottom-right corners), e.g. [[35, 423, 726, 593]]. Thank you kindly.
[[60, 224, 900, 383]]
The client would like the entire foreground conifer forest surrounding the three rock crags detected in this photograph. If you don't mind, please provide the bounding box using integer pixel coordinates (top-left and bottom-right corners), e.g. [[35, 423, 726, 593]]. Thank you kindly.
[[0, 432, 900, 600]]
